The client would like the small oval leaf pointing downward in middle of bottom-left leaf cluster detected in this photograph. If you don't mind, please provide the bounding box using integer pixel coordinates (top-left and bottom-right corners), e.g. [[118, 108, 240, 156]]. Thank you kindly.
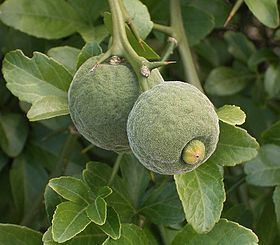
[[86, 196, 107, 225]]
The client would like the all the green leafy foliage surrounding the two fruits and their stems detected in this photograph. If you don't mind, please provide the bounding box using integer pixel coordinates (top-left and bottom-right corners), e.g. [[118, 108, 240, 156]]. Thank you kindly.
[[0, 0, 280, 245]]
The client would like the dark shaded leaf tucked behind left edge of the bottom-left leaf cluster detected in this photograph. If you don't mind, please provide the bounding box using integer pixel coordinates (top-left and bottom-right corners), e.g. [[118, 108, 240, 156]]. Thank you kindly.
[[44, 185, 65, 222]]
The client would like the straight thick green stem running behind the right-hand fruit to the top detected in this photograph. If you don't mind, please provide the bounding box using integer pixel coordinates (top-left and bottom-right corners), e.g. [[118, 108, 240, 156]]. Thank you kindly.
[[170, 0, 203, 92]]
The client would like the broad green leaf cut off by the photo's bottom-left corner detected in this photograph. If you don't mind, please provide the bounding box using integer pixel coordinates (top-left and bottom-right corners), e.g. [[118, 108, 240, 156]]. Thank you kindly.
[[0, 224, 42, 245]]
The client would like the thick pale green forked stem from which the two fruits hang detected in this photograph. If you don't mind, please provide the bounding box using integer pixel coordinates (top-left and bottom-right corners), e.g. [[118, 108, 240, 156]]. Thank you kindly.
[[108, 0, 149, 91]]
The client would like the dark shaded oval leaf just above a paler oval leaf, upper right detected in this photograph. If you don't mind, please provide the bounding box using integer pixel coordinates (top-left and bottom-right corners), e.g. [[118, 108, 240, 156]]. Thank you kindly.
[[224, 31, 256, 64]]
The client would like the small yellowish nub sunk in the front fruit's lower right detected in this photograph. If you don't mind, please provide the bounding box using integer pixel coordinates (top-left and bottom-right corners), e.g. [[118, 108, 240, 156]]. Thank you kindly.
[[182, 140, 205, 164]]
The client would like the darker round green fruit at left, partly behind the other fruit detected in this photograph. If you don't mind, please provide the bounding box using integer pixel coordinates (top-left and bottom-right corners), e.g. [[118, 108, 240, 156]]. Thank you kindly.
[[68, 56, 163, 152]]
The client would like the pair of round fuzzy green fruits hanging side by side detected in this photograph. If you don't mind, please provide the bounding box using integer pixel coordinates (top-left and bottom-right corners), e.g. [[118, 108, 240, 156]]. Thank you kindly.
[[68, 56, 219, 175]]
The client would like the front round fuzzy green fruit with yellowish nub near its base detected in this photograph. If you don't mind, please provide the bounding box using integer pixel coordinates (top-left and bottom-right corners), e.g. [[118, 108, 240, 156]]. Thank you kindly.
[[127, 81, 219, 175]]
